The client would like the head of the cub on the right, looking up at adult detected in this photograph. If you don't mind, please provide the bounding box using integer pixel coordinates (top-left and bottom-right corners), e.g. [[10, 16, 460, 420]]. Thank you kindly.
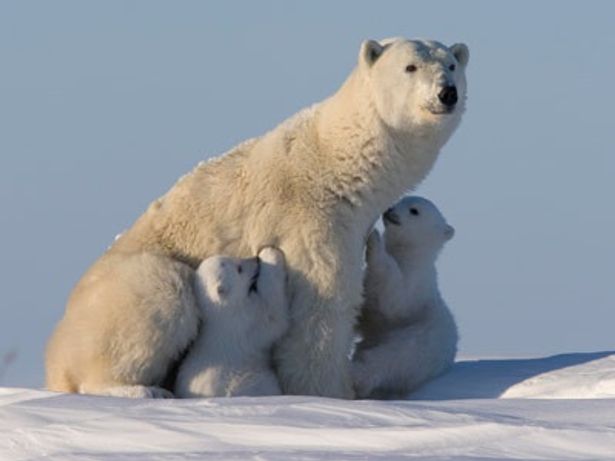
[[382, 196, 455, 253]]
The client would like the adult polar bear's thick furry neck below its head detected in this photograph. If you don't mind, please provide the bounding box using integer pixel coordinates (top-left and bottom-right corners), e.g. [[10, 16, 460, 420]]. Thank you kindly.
[[315, 70, 443, 226]]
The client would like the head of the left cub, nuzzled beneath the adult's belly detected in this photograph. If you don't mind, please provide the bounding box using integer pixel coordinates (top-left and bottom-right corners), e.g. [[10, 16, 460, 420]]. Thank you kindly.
[[195, 256, 260, 325]]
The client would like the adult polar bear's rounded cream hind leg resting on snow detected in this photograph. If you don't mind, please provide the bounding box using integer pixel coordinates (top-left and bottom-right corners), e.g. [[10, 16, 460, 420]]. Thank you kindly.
[[47, 253, 200, 397]]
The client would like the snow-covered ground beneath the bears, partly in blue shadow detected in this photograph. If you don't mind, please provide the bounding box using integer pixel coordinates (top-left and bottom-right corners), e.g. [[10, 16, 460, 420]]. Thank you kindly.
[[0, 352, 615, 461]]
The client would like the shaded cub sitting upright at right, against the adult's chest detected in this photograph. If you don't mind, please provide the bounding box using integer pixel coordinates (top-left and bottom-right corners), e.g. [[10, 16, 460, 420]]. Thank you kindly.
[[353, 196, 458, 398]]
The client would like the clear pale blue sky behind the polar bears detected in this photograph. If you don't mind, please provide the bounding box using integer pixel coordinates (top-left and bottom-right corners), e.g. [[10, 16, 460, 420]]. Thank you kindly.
[[0, 0, 615, 386]]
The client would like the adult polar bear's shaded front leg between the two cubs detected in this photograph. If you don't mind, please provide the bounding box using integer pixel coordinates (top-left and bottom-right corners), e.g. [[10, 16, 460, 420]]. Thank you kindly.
[[275, 248, 362, 399]]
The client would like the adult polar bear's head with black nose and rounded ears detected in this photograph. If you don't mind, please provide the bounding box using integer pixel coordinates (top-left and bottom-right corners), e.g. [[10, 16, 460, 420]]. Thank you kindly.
[[359, 38, 469, 131]]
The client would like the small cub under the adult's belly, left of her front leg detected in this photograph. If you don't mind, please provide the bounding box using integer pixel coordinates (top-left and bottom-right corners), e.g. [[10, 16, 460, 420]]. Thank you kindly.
[[175, 247, 289, 397]]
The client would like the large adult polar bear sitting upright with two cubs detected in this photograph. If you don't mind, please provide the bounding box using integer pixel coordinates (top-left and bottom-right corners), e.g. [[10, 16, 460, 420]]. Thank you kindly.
[[46, 39, 469, 398]]
